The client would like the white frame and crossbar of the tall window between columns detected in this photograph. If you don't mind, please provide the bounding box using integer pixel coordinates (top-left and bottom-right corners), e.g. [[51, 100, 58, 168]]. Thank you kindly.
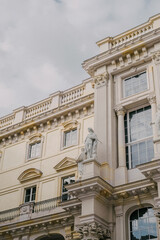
[[124, 104, 153, 170]]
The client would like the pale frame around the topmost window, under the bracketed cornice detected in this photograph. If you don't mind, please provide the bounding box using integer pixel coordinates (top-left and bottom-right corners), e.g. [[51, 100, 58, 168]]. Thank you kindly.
[[122, 69, 149, 99]]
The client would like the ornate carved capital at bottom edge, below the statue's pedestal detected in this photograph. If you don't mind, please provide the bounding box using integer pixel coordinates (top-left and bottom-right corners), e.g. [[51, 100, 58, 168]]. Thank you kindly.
[[76, 223, 111, 240]]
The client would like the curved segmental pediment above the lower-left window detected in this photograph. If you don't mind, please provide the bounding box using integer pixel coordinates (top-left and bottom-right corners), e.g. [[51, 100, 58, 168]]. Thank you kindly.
[[18, 168, 43, 183]]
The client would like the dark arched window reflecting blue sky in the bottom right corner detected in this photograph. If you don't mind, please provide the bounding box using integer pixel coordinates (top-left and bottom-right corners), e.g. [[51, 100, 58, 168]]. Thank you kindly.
[[130, 207, 158, 240]]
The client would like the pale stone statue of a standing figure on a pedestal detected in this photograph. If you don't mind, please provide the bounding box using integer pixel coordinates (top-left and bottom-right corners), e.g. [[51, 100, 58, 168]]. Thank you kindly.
[[84, 128, 98, 159]]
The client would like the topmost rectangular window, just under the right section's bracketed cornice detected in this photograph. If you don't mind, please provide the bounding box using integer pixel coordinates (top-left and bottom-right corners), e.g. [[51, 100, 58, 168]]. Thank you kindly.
[[123, 72, 148, 97]]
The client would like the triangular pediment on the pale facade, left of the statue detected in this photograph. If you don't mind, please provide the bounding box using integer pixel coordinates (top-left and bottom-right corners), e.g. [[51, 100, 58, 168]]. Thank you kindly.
[[54, 157, 77, 171]]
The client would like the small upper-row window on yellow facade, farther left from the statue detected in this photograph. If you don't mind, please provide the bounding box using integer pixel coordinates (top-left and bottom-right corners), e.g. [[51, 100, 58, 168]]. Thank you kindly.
[[28, 141, 41, 159]]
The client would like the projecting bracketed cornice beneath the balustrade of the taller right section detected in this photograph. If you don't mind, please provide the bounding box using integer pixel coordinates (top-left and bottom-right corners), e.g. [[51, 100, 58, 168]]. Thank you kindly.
[[82, 28, 160, 76]]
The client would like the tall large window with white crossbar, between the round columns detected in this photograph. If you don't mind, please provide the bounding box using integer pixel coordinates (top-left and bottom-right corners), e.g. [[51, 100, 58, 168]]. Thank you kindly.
[[124, 106, 154, 169]]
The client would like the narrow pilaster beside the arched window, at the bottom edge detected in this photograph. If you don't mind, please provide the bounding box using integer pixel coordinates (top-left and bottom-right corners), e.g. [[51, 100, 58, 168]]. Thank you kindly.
[[115, 206, 125, 240]]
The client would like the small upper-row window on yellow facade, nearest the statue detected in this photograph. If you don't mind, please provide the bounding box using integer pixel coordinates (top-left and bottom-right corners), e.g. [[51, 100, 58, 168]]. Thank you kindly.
[[63, 128, 77, 147]]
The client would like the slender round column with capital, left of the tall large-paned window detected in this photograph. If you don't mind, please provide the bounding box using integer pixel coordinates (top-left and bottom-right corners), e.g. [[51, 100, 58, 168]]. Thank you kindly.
[[115, 105, 128, 185]]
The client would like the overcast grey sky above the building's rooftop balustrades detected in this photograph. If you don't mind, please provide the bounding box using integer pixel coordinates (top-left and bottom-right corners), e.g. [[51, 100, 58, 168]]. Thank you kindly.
[[0, 0, 160, 117]]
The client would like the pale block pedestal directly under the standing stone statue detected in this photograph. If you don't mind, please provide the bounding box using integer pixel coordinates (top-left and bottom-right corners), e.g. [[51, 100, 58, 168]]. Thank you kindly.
[[82, 158, 101, 180]]
